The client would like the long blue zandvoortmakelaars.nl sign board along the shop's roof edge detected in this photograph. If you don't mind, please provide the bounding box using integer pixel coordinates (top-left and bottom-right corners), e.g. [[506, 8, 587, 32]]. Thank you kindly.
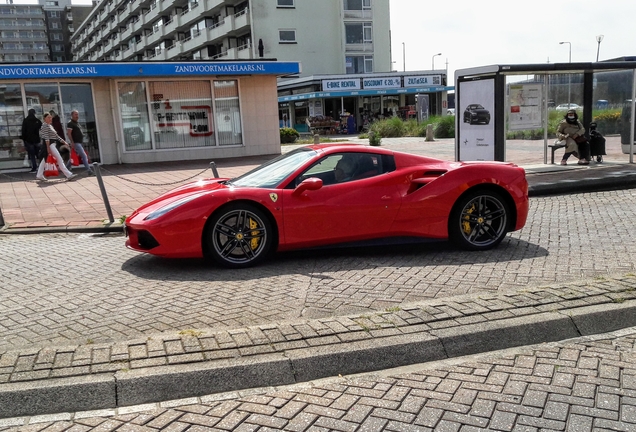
[[0, 61, 300, 79]]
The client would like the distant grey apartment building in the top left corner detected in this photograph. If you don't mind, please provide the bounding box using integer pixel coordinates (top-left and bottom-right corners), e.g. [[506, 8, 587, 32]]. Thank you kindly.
[[0, 0, 92, 63]]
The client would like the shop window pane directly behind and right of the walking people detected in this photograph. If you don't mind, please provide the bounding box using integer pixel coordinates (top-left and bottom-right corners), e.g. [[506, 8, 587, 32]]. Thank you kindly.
[[57, 83, 100, 162]]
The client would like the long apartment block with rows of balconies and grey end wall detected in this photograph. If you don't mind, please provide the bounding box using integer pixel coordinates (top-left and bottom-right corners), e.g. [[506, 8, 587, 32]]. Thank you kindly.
[[72, 0, 391, 76]]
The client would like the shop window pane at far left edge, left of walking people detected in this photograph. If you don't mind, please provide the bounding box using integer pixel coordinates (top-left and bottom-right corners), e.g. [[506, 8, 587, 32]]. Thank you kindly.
[[0, 84, 26, 169]]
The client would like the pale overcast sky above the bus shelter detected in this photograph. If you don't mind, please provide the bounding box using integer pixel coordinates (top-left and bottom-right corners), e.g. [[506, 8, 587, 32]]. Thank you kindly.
[[390, 0, 636, 85]]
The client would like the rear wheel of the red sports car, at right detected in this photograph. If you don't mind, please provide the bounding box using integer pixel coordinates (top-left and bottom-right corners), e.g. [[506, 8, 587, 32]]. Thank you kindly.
[[448, 190, 511, 251]]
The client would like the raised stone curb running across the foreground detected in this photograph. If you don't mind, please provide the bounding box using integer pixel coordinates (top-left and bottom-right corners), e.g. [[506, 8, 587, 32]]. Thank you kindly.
[[0, 300, 636, 418]]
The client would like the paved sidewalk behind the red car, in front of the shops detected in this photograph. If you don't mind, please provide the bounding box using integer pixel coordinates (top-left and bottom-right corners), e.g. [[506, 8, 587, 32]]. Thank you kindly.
[[0, 137, 636, 233]]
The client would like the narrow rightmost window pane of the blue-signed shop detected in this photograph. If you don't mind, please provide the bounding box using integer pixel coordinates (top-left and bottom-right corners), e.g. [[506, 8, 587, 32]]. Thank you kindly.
[[214, 80, 243, 146]]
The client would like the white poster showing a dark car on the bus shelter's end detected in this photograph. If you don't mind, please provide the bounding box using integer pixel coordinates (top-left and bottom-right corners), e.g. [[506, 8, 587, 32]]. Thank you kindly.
[[457, 78, 495, 161]]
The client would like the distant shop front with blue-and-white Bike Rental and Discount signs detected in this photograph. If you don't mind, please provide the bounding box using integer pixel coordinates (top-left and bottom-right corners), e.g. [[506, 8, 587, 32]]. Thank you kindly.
[[278, 71, 453, 135]]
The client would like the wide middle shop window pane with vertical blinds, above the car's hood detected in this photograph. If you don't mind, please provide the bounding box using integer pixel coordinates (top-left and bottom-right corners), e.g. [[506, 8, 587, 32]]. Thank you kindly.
[[148, 81, 214, 149]]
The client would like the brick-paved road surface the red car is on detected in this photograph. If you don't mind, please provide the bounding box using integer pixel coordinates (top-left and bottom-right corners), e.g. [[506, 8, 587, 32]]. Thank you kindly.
[[0, 190, 636, 352]]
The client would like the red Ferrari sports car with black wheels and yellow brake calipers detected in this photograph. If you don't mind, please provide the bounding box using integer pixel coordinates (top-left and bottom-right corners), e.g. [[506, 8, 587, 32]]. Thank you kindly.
[[125, 144, 528, 268]]
